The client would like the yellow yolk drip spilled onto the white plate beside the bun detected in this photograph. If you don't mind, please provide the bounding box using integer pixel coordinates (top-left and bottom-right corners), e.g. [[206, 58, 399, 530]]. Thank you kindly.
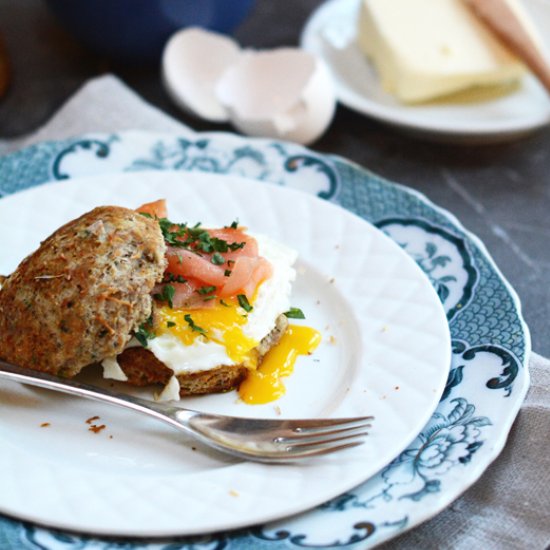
[[239, 325, 321, 405]]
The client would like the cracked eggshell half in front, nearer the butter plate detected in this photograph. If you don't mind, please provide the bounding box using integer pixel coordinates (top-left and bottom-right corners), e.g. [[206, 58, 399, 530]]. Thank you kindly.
[[216, 48, 336, 144]]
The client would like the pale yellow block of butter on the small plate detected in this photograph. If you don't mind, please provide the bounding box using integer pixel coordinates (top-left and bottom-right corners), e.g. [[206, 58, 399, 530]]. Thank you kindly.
[[358, 0, 536, 103]]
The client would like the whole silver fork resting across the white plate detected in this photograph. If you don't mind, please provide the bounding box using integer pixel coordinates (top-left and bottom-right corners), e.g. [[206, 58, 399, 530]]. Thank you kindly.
[[0, 361, 374, 462]]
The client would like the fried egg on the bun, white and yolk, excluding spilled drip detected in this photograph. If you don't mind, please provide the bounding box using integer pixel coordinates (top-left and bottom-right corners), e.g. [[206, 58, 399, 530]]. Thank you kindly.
[[148, 235, 297, 399]]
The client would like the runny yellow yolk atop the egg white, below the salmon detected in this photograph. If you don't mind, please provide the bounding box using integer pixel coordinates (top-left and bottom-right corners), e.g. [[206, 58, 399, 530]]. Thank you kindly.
[[155, 298, 259, 369]]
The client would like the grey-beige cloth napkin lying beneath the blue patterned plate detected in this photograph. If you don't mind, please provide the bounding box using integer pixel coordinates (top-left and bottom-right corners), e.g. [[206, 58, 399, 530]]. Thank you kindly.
[[0, 76, 550, 550]]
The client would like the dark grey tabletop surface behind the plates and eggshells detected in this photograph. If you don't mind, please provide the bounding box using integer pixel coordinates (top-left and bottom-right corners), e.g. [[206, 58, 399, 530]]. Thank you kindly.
[[0, 0, 550, 362]]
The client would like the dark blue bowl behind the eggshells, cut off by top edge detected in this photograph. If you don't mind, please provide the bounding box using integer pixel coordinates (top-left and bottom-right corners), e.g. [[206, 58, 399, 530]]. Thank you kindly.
[[47, 0, 254, 63]]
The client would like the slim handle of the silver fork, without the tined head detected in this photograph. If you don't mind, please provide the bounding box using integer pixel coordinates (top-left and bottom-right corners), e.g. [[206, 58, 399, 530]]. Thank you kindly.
[[0, 360, 201, 433]]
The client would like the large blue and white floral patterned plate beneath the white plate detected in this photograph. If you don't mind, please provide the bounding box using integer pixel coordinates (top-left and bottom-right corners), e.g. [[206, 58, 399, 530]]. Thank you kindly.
[[0, 132, 530, 550]]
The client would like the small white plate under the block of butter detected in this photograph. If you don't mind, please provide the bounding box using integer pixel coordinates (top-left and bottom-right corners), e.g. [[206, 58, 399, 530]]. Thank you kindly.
[[301, 0, 550, 143]]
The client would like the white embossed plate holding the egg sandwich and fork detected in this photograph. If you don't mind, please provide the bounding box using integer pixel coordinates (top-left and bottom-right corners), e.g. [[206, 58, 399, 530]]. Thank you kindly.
[[0, 172, 451, 536]]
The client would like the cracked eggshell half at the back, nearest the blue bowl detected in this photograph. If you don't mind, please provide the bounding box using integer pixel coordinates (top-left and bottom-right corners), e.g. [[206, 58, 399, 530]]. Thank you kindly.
[[162, 27, 241, 122]]
